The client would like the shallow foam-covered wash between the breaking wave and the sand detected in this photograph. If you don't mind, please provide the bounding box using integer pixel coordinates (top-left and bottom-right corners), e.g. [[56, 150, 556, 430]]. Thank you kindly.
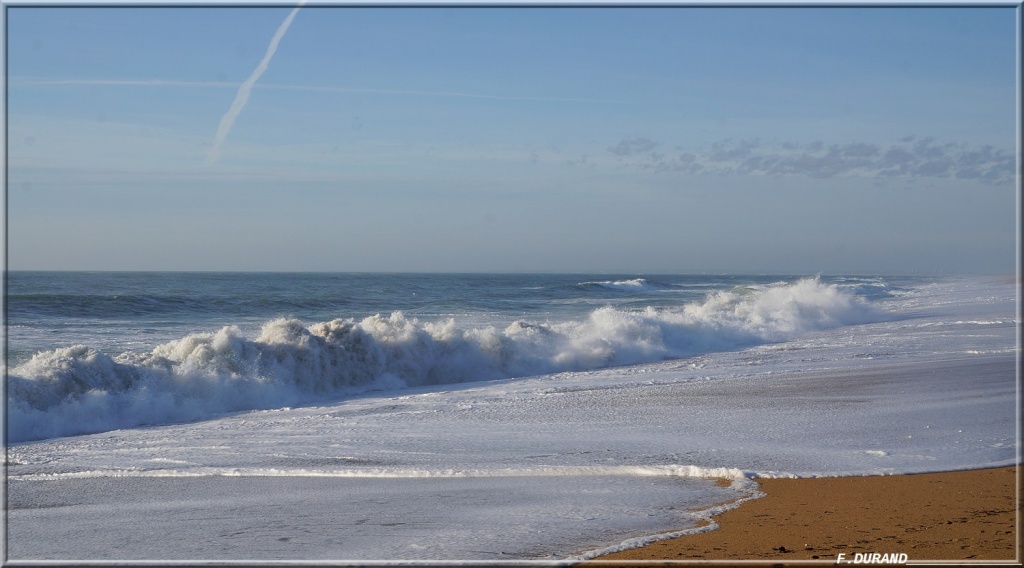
[[8, 356, 1013, 562]]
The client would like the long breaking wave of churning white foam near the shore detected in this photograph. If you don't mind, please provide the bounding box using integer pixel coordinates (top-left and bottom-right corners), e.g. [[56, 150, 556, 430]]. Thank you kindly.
[[7, 278, 879, 442]]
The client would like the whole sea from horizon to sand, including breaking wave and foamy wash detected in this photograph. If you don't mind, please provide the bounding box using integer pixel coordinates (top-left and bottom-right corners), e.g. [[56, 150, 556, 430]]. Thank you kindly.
[[5, 271, 1020, 562]]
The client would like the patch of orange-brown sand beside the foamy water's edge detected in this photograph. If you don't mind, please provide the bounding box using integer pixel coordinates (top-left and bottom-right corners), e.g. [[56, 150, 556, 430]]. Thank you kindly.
[[592, 468, 1021, 565]]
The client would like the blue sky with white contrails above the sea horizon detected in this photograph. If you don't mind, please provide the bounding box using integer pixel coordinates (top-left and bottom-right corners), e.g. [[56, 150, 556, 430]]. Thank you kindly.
[[5, 4, 1019, 273]]
